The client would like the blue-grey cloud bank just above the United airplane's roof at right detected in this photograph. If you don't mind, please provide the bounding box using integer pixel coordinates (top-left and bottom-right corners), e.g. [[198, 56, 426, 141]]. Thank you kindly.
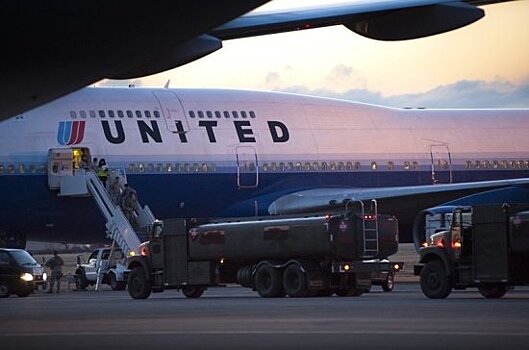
[[283, 80, 529, 108]]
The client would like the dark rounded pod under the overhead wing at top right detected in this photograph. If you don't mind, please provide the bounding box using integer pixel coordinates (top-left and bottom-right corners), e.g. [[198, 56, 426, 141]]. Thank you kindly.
[[346, 2, 485, 41]]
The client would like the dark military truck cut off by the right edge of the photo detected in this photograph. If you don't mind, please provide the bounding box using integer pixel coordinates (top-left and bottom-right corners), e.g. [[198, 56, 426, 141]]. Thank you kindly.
[[414, 204, 529, 299]]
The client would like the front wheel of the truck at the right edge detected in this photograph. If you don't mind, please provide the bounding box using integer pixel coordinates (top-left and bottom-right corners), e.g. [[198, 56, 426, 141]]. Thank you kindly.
[[421, 260, 452, 299]]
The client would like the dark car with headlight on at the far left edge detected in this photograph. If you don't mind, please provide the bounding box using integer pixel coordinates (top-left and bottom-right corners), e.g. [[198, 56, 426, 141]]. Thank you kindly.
[[0, 249, 47, 298]]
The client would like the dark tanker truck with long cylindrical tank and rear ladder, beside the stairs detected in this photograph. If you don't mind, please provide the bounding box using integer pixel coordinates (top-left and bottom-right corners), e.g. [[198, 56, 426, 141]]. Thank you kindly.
[[127, 202, 402, 299]]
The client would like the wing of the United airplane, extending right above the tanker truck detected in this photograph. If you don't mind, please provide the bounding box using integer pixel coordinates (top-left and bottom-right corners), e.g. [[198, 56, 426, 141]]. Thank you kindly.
[[268, 178, 529, 242]]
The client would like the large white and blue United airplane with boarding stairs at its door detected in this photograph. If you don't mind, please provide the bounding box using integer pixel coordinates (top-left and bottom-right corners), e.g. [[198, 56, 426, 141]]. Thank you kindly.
[[0, 88, 529, 247]]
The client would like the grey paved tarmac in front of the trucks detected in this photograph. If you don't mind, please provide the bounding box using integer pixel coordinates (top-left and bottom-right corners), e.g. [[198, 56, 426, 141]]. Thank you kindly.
[[0, 283, 529, 350]]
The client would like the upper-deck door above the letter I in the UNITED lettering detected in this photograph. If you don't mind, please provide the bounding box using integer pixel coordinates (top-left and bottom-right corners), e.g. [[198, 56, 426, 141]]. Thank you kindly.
[[152, 89, 189, 134]]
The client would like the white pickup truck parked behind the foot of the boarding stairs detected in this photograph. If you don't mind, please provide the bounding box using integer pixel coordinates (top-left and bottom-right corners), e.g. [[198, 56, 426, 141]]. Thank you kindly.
[[75, 247, 127, 290]]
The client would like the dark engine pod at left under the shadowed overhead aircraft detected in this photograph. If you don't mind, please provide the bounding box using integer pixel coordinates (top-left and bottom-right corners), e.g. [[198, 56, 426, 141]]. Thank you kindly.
[[108, 34, 222, 79]]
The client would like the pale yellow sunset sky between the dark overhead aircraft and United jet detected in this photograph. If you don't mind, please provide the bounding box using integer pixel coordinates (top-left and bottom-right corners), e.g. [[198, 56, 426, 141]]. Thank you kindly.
[[97, 0, 529, 108]]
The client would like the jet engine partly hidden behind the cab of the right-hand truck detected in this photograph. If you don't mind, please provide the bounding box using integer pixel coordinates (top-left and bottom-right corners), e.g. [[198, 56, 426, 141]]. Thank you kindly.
[[413, 205, 457, 252]]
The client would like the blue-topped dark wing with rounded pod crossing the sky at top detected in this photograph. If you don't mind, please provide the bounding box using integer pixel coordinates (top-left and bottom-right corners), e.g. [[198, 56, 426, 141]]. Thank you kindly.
[[209, 0, 512, 40]]
